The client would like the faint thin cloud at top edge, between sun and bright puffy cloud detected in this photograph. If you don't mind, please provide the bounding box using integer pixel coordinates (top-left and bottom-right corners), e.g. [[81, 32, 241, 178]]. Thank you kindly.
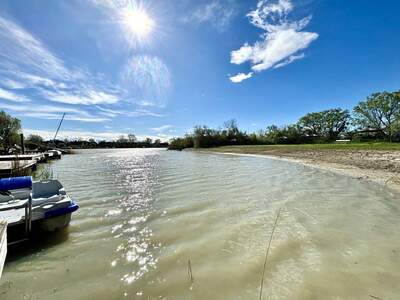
[[182, 0, 238, 32]]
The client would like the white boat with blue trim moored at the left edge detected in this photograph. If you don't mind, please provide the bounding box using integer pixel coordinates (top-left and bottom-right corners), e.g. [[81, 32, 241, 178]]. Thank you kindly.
[[0, 176, 79, 239]]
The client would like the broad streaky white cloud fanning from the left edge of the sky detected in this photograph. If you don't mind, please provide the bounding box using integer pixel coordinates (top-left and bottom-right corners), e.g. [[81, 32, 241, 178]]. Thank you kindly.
[[0, 16, 121, 105]]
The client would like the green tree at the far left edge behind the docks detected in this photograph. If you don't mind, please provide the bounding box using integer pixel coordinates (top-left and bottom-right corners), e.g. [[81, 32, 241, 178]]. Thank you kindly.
[[0, 111, 21, 153]]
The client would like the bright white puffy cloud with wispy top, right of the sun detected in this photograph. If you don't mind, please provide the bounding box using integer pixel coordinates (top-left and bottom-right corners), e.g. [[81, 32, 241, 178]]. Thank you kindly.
[[230, 0, 318, 83]]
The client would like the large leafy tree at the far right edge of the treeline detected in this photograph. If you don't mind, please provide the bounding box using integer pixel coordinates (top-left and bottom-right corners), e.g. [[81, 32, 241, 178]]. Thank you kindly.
[[354, 91, 400, 142]]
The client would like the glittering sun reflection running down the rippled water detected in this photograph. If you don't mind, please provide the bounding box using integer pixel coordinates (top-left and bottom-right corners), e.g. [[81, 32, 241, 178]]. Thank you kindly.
[[107, 150, 160, 285]]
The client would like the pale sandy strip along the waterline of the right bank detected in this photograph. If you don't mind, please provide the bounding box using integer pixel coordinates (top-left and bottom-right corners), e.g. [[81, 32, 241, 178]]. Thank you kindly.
[[191, 149, 400, 193]]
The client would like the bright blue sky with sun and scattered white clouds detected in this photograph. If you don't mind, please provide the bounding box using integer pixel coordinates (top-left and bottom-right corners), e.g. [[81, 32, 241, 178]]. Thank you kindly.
[[0, 0, 400, 140]]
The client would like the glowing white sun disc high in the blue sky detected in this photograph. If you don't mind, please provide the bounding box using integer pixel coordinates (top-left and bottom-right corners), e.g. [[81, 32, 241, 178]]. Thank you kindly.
[[122, 8, 155, 39]]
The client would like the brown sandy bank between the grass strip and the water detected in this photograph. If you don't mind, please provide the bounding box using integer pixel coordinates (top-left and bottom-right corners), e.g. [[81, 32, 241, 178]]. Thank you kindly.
[[198, 146, 400, 191]]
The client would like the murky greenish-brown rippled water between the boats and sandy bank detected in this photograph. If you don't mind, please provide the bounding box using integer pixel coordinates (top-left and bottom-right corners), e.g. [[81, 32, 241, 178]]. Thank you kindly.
[[0, 149, 400, 300]]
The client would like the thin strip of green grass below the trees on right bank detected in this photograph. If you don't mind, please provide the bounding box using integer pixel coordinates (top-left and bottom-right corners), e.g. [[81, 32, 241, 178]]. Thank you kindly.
[[201, 142, 400, 154]]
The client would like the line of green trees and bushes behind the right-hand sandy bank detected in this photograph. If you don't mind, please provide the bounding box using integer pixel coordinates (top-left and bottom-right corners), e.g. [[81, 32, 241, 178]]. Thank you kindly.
[[169, 91, 400, 150]]
